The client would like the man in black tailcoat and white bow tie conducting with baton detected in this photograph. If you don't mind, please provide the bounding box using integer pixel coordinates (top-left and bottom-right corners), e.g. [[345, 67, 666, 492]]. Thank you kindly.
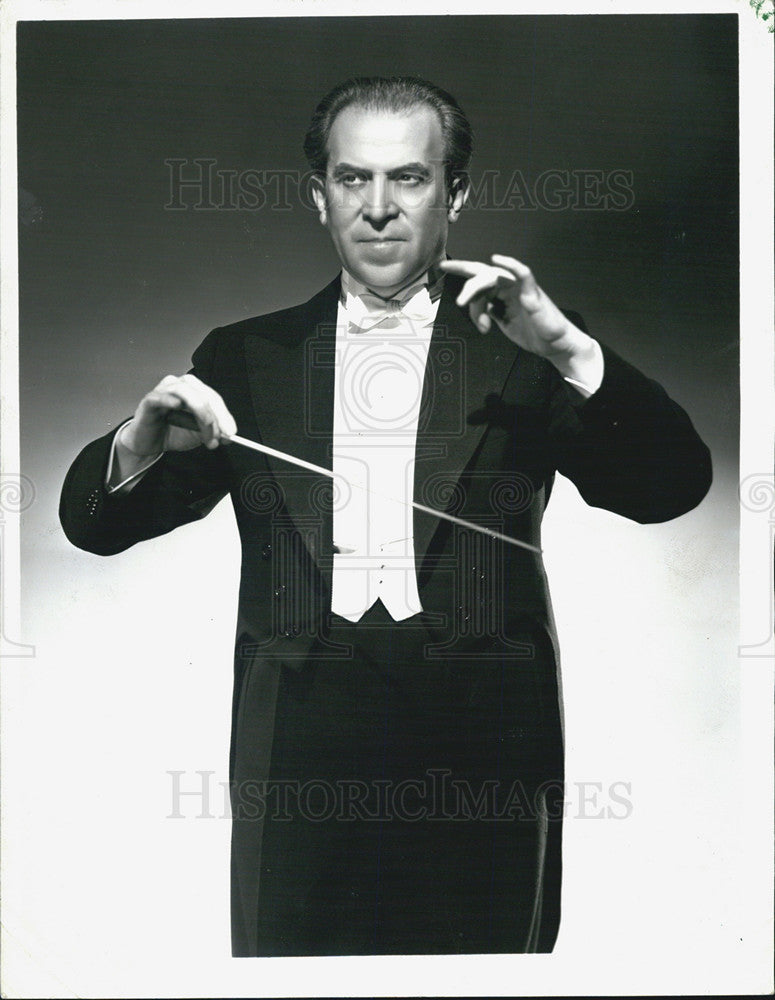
[[61, 78, 711, 955]]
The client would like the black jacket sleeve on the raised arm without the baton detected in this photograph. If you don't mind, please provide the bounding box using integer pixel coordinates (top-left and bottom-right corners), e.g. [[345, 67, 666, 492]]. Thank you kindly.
[[549, 344, 712, 524]]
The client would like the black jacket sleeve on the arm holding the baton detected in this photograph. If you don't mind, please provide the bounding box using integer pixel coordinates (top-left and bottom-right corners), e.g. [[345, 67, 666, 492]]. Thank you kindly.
[[59, 331, 229, 555]]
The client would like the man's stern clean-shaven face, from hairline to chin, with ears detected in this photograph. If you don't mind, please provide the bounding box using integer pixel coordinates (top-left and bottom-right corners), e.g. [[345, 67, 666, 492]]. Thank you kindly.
[[314, 104, 465, 298]]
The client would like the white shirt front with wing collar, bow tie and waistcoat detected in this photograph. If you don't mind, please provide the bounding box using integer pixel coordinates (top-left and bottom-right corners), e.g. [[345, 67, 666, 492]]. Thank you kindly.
[[331, 271, 441, 622]]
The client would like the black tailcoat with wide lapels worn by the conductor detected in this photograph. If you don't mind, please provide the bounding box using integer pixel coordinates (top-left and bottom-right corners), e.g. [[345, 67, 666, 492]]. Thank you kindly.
[[60, 276, 711, 953]]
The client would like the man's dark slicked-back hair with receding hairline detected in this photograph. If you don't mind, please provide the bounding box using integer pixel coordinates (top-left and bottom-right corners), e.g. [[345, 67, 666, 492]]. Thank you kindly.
[[304, 76, 473, 193]]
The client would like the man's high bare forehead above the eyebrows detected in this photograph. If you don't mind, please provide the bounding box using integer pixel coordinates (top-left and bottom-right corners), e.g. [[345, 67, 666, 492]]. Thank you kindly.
[[328, 104, 444, 170]]
